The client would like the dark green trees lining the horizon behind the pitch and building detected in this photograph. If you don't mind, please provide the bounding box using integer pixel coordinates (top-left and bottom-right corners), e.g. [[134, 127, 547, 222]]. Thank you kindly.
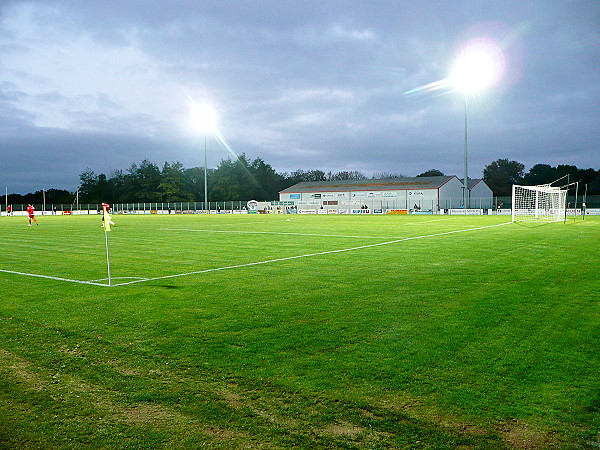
[[0, 154, 600, 204]]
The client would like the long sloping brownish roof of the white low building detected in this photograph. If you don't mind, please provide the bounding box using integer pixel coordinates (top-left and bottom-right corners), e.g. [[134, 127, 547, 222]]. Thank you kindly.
[[279, 175, 456, 194]]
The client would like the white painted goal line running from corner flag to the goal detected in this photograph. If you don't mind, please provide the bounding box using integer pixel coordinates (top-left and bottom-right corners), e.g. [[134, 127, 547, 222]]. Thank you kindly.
[[110, 222, 512, 287]]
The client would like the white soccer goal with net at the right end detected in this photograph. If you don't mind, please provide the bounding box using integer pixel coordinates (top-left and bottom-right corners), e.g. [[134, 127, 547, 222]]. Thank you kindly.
[[512, 184, 567, 223]]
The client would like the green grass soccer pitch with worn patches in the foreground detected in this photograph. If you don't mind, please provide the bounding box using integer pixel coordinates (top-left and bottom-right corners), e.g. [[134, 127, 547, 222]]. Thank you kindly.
[[0, 215, 600, 449]]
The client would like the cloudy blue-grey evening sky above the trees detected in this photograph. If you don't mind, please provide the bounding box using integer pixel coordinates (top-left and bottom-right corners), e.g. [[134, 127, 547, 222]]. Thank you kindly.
[[0, 0, 600, 194]]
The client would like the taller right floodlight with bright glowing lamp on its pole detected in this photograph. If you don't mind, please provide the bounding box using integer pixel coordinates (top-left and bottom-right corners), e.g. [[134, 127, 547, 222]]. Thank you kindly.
[[450, 39, 504, 209]]
